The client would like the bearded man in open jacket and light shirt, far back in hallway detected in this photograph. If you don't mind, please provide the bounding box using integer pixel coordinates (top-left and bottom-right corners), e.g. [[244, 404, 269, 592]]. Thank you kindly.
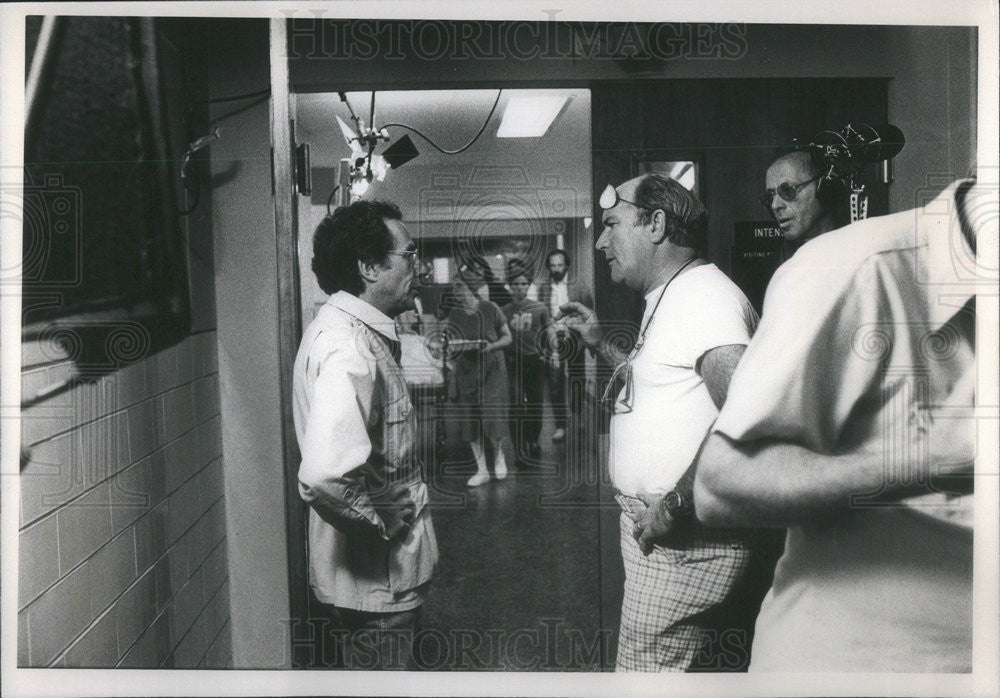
[[528, 250, 594, 442]]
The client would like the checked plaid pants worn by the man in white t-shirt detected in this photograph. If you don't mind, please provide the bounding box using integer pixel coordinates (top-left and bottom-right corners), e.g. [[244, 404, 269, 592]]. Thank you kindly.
[[615, 512, 751, 672]]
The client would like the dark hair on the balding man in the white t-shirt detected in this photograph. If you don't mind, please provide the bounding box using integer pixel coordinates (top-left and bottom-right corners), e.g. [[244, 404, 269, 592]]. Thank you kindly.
[[635, 172, 708, 252]]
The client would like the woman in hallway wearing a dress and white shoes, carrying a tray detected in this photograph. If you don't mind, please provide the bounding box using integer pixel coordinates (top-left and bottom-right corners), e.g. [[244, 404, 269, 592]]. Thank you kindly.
[[445, 280, 511, 487]]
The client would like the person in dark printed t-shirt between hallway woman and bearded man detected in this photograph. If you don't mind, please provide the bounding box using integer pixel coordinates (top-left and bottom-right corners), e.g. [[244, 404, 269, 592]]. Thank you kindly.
[[501, 259, 553, 459]]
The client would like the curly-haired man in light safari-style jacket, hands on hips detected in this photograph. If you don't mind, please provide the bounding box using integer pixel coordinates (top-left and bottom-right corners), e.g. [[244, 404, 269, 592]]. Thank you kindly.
[[292, 201, 438, 669]]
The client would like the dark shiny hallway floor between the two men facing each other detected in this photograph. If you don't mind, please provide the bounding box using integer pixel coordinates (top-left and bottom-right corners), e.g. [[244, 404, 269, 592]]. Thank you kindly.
[[415, 392, 617, 671]]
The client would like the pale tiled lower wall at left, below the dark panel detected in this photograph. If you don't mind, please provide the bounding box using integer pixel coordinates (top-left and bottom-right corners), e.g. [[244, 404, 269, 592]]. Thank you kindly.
[[18, 331, 232, 668]]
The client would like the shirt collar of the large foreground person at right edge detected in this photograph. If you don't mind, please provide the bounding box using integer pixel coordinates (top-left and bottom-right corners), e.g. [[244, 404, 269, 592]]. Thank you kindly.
[[914, 181, 985, 327]]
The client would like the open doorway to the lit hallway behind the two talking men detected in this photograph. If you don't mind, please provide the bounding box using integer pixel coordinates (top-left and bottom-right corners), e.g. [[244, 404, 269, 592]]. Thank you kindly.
[[289, 88, 611, 671]]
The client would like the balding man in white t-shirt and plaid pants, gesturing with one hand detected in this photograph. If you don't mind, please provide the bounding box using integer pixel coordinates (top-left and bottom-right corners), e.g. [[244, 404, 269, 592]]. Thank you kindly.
[[562, 174, 757, 671]]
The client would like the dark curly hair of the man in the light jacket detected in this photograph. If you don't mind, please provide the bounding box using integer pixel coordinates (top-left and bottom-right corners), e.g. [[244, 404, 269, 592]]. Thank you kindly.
[[312, 201, 403, 295]]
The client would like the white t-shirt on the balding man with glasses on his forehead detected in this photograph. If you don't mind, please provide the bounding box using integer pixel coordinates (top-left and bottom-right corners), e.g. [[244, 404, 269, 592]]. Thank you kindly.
[[606, 264, 757, 497]]
